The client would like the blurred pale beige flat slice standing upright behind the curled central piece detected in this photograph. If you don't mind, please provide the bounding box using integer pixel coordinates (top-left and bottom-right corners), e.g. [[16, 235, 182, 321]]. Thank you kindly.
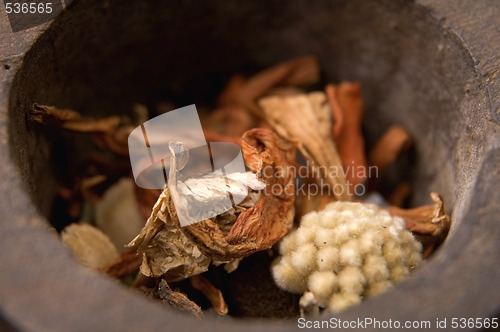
[[95, 178, 144, 251]]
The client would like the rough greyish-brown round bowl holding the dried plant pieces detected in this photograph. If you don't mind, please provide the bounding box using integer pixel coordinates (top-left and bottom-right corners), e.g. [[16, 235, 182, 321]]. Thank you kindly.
[[0, 0, 500, 331]]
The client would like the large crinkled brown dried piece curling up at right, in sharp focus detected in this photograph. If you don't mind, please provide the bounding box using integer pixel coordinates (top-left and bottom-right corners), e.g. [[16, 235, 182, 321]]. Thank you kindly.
[[130, 129, 295, 281]]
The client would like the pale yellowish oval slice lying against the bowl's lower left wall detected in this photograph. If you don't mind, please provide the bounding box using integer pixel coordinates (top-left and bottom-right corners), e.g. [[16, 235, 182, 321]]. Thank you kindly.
[[61, 223, 118, 269]]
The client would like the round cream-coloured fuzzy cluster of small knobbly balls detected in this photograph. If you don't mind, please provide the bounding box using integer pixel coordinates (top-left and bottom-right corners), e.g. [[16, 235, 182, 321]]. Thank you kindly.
[[272, 202, 422, 312]]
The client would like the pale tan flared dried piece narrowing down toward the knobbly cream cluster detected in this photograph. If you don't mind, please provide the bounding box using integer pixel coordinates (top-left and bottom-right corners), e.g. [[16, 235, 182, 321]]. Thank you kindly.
[[259, 92, 351, 201]]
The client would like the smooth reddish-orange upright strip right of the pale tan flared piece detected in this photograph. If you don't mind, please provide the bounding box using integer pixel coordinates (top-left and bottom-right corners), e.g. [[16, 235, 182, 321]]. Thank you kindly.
[[325, 82, 367, 188]]
